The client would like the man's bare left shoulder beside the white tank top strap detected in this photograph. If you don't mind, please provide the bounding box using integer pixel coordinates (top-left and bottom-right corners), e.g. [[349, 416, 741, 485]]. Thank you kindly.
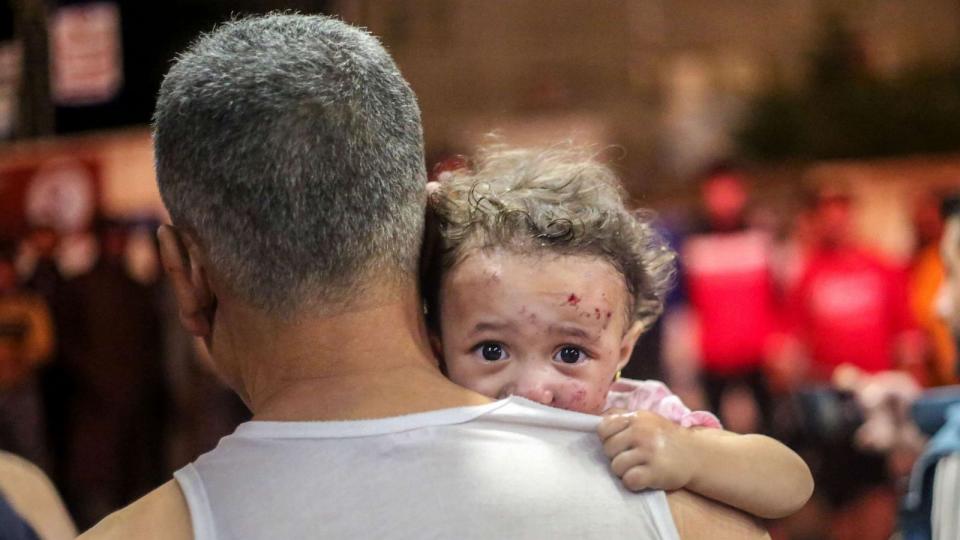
[[80, 480, 193, 540]]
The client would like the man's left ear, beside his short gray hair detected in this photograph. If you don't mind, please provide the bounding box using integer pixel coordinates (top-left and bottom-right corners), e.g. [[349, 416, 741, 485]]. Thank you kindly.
[[157, 225, 216, 338]]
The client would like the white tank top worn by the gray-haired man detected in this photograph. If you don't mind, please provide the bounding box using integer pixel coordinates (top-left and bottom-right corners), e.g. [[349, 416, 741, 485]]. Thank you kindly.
[[175, 397, 679, 540]]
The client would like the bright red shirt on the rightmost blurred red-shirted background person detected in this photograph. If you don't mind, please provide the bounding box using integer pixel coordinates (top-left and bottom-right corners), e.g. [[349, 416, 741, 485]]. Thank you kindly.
[[790, 247, 913, 373]]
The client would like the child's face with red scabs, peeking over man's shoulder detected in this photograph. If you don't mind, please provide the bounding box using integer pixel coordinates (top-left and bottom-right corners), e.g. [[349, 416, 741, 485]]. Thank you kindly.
[[440, 250, 640, 414]]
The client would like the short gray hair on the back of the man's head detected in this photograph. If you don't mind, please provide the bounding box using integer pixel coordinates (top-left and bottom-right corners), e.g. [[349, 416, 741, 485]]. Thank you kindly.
[[154, 14, 426, 314]]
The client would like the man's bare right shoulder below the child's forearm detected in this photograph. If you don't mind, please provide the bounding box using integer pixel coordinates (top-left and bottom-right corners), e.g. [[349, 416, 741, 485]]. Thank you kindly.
[[667, 490, 770, 540]]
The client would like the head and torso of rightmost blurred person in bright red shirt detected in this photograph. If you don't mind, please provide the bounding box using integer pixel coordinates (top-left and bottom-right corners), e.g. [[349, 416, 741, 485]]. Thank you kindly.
[[788, 188, 922, 382]]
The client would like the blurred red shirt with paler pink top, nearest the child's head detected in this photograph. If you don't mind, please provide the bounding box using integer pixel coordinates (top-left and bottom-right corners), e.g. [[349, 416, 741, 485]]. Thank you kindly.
[[683, 230, 776, 372]]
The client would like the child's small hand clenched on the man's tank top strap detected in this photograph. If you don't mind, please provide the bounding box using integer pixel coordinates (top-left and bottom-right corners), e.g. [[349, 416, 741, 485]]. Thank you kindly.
[[597, 411, 698, 491]]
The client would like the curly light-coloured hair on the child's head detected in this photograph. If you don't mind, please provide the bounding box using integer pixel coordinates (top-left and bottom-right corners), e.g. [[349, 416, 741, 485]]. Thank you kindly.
[[425, 144, 677, 327]]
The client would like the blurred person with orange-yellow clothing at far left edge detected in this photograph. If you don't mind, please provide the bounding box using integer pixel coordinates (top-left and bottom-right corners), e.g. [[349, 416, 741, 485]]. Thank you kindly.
[[0, 247, 54, 463]]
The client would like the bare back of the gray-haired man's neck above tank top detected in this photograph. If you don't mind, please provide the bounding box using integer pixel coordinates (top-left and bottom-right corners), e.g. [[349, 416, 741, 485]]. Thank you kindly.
[[214, 288, 489, 421]]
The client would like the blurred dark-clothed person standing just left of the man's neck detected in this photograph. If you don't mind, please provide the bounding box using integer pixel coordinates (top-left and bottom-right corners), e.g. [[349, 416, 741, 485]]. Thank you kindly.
[[61, 219, 166, 528]]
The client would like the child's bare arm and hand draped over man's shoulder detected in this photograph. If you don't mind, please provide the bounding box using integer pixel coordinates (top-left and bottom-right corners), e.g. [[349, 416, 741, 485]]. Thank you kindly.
[[598, 411, 813, 518]]
